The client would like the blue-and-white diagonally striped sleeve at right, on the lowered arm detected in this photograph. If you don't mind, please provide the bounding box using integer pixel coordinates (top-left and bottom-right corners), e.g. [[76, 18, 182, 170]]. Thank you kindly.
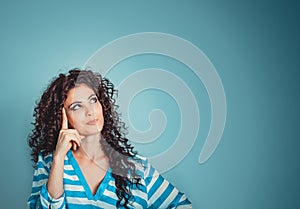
[[144, 160, 192, 209]]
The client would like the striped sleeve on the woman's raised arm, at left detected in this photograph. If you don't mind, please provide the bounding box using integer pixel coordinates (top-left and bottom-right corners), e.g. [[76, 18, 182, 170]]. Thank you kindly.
[[27, 153, 66, 209]]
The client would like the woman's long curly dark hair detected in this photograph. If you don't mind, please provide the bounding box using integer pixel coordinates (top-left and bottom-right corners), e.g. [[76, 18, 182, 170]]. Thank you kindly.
[[28, 68, 140, 208]]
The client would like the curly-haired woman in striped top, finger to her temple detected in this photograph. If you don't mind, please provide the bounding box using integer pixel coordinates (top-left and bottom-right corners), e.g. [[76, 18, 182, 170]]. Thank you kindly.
[[28, 69, 191, 209]]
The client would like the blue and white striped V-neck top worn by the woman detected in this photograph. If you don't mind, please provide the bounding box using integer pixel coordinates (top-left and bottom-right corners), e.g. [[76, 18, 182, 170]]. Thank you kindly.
[[27, 150, 192, 209]]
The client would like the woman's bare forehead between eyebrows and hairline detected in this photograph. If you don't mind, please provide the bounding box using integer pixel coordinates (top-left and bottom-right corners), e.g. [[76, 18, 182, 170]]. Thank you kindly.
[[65, 84, 95, 104]]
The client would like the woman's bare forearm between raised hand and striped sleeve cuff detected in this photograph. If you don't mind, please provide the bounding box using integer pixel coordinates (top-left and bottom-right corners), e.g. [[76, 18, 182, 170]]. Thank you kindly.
[[47, 155, 64, 198]]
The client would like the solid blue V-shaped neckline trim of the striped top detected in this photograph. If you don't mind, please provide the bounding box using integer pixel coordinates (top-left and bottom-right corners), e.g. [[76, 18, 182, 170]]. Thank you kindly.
[[68, 150, 111, 200]]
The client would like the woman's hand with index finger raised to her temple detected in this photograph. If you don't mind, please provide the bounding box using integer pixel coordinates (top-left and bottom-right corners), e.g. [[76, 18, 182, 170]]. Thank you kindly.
[[54, 107, 83, 159]]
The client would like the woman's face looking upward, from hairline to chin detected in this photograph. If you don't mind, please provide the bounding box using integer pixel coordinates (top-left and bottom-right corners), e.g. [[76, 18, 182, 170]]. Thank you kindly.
[[64, 84, 104, 136]]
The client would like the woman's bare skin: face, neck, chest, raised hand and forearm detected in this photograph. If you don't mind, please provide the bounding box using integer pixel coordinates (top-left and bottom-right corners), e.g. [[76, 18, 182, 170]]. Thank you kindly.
[[47, 84, 109, 198]]
